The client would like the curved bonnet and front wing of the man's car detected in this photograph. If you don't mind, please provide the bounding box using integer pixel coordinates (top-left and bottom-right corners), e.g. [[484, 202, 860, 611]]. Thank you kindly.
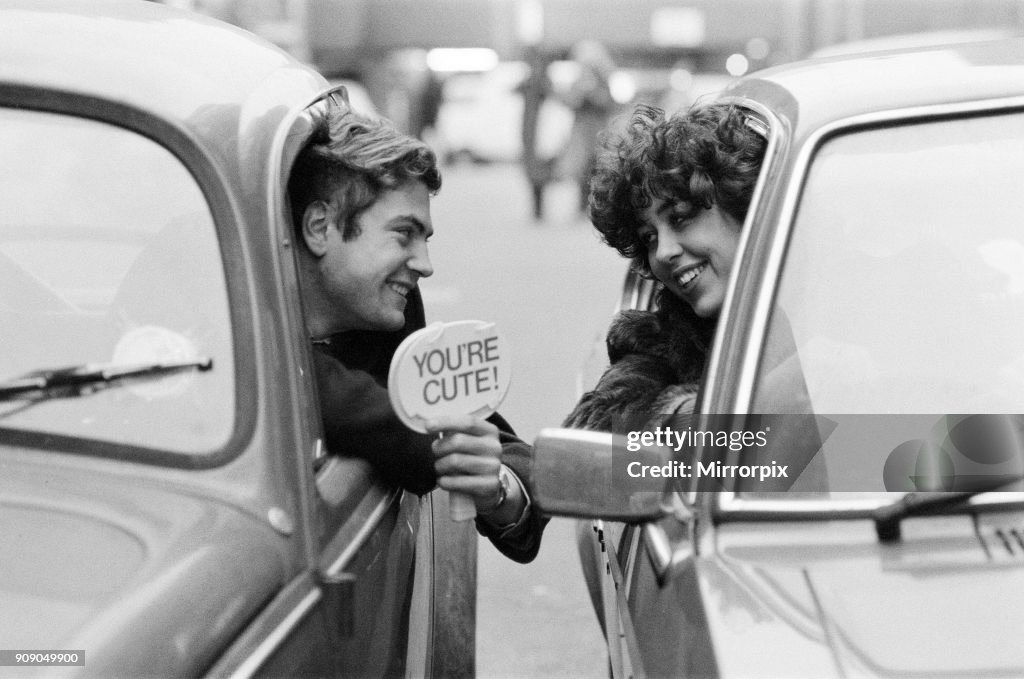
[[0, 453, 288, 676]]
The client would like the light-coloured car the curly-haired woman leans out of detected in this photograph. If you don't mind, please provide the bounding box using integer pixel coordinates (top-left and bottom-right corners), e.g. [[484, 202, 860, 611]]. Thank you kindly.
[[535, 40, 1024, 679]]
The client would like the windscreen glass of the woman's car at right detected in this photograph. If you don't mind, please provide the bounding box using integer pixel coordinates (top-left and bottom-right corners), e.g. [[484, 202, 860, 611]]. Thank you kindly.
[[752, 107, 1024, 498]]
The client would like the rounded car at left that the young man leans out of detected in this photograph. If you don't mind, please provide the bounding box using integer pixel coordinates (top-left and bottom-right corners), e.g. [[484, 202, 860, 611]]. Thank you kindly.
[[0, 0, 476, 677]]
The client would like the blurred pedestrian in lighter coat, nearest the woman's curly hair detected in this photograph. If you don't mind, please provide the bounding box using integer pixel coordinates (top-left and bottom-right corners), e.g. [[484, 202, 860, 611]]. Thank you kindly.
[[558, 40, 615, 211]]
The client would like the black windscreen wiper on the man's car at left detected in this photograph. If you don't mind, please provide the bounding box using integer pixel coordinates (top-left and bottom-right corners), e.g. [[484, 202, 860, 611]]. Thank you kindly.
[[0, 358, 213, 401]]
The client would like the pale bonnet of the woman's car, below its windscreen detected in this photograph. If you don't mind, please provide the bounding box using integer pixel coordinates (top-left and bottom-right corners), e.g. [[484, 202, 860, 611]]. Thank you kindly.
[[703, 516, 1024, 676]]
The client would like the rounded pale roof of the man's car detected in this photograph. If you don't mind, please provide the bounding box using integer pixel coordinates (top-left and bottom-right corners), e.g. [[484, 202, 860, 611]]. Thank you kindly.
[[0, 0, 327, 153]]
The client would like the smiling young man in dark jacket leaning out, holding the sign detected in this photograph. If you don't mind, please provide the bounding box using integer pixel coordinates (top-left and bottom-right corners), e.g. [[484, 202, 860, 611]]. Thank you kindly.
[[289, 103, 544, 562]]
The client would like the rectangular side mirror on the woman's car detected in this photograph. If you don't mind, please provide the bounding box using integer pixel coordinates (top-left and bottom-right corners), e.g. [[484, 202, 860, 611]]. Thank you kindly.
[[532, 429, 668, 523]]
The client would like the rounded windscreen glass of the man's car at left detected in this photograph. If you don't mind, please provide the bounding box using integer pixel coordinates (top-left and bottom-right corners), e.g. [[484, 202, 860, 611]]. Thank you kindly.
[[0, 109, 234, 454]]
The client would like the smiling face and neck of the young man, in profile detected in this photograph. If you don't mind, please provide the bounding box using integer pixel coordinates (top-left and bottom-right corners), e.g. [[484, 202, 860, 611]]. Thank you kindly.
[[319, 180, 434, 332]]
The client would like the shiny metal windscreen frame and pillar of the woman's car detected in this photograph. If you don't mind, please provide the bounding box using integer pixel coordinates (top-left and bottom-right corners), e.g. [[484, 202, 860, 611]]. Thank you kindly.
[[712, 96, 1024, 523]]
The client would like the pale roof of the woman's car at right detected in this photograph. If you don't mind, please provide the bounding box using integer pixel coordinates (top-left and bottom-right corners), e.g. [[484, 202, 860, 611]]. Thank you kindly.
[[724, 38, 1024, 138]]
